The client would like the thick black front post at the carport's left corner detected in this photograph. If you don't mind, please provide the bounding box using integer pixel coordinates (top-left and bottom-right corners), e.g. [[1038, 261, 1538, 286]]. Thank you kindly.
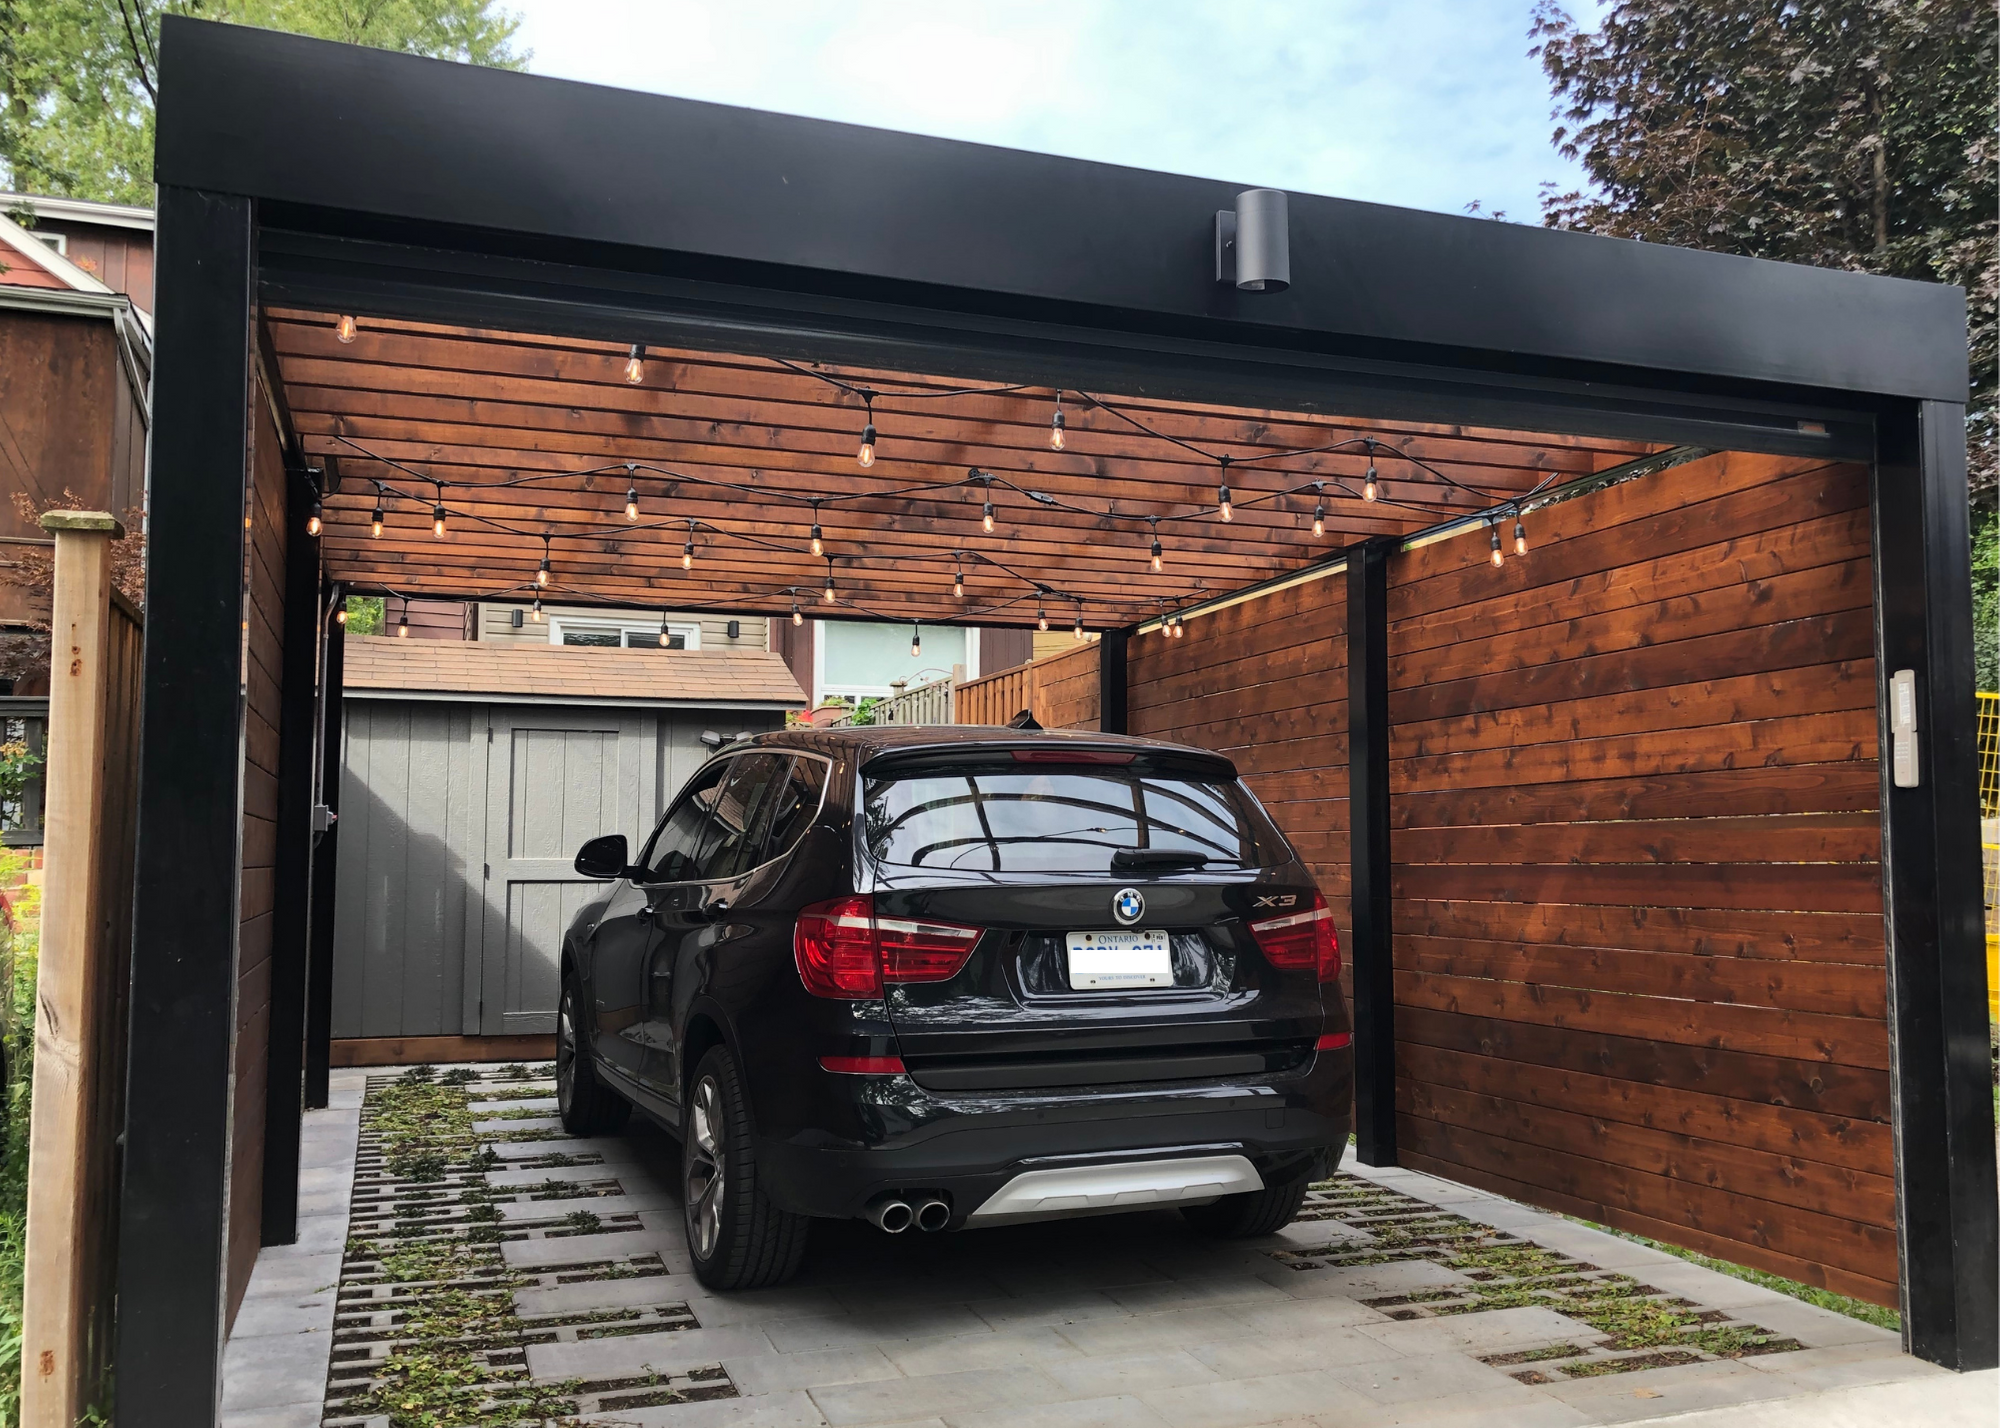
[[118, 186, 254, 1428]]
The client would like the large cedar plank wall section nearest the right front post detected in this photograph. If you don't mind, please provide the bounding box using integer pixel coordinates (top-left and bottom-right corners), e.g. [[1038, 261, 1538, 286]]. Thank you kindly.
[[1392, 454, 1896, 1304]]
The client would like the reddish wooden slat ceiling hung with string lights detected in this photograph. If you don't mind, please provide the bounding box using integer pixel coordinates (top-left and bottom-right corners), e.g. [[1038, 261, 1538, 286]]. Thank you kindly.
[[266, 310, 1658, 628]]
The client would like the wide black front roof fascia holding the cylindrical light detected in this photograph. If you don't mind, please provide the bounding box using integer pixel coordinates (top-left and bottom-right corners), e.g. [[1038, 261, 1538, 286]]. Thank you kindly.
[[156, 18, 1968, 402]]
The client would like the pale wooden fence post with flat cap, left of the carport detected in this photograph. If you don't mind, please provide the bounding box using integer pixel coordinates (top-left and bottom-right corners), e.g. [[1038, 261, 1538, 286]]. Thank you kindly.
[[20, 510, 142, 1428]]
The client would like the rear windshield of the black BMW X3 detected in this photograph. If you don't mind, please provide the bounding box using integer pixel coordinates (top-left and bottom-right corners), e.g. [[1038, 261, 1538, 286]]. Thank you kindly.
[[864, 764, 1278, 872]]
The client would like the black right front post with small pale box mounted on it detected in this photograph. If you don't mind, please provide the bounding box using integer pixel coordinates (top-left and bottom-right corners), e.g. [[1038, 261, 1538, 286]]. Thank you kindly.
[[1874, 402, 2000, 1370]]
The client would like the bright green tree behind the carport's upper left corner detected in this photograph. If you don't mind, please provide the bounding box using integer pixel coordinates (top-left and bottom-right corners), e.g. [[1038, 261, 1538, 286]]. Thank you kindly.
[[0, 0, 528, 206]]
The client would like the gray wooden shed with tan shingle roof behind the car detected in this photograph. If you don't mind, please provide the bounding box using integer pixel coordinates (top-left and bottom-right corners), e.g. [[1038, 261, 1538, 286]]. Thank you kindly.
[[332, 638, 806, 1060]]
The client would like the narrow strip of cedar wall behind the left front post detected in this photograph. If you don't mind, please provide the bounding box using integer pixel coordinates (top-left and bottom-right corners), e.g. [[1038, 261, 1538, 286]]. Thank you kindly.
[[228, 370, 286, 1324]]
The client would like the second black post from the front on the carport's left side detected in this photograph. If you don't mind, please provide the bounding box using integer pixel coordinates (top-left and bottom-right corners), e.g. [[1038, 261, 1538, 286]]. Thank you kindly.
[[264, 464, 320, 1244]]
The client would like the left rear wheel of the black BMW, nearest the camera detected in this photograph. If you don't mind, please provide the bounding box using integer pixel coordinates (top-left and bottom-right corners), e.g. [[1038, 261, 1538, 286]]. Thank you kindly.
[[680, 1046, 812, 1290]]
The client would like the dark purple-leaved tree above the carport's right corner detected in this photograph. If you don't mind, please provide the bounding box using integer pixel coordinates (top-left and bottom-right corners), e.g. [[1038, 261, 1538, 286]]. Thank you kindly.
[[1532, 0, 2000, 494]]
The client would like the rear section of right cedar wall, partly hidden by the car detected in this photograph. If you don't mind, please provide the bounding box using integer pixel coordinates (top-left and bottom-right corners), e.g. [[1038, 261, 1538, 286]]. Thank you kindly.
[[1126, 574, 1352, 968]]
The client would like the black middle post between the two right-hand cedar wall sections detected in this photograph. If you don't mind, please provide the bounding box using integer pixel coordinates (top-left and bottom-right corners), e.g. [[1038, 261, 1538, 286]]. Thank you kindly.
[[1348, 538, 1398, 1166]]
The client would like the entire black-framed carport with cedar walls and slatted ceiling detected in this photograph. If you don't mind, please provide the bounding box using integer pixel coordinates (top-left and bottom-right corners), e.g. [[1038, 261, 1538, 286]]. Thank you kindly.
[[118, 20, 1996, 1426]]
